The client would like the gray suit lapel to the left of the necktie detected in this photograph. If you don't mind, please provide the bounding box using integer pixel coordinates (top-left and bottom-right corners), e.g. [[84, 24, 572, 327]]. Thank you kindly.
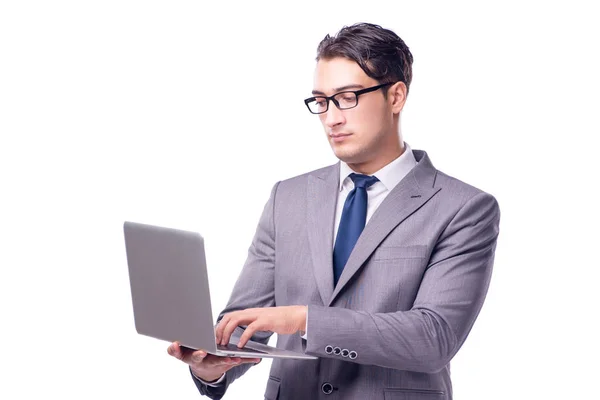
[[307, 163, 340, 304]]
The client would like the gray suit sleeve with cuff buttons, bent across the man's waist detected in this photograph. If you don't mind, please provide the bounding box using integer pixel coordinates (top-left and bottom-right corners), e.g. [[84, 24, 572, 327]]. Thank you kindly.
[[306, 192, 500, 373]]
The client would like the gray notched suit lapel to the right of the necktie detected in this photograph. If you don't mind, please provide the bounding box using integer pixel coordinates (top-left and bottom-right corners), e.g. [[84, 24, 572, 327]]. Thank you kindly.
[[328, 150, 441, 306]]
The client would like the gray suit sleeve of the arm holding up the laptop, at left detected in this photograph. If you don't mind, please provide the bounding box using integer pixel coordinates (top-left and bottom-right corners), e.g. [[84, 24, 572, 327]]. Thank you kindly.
[[192, 182, 279, 399]]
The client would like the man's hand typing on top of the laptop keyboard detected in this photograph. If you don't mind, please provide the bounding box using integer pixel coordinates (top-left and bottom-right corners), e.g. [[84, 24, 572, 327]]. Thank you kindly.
[[215, 306, 308, 348]]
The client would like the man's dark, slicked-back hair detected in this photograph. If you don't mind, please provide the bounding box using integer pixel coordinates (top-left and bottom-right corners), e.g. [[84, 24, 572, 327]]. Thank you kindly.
[[317, 23, 413, 92]]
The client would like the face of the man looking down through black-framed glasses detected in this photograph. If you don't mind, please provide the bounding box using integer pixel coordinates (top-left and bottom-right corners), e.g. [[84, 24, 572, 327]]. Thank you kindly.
[[313, 57, 398, 164]]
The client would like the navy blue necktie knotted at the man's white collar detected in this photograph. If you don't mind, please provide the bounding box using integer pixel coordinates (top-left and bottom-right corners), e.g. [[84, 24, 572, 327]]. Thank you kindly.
[[333, 174, 379, 286]]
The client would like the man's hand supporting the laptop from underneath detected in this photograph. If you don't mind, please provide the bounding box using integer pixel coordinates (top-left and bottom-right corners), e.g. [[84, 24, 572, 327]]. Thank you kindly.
[[167, 342, 260, 382]]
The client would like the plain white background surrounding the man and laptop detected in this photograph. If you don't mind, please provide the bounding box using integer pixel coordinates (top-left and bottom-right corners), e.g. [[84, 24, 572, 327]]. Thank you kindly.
[[0, 0, 600, 400]]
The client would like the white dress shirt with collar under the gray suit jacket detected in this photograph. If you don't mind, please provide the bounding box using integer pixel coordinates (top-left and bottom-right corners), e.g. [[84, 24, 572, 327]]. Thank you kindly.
[[194, 142, 417, 386]]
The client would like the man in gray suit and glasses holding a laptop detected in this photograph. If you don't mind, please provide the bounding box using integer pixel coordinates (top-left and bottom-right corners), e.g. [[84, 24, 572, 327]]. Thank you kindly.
[[168, 24, 500, 399]]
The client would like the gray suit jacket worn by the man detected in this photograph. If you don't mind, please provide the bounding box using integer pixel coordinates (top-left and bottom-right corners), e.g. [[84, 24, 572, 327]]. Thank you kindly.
[[194, 150, 500, 400]]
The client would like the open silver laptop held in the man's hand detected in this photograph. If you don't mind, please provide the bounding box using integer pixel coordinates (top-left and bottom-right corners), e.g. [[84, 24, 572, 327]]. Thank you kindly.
[[123, 221, 317, 360]]
